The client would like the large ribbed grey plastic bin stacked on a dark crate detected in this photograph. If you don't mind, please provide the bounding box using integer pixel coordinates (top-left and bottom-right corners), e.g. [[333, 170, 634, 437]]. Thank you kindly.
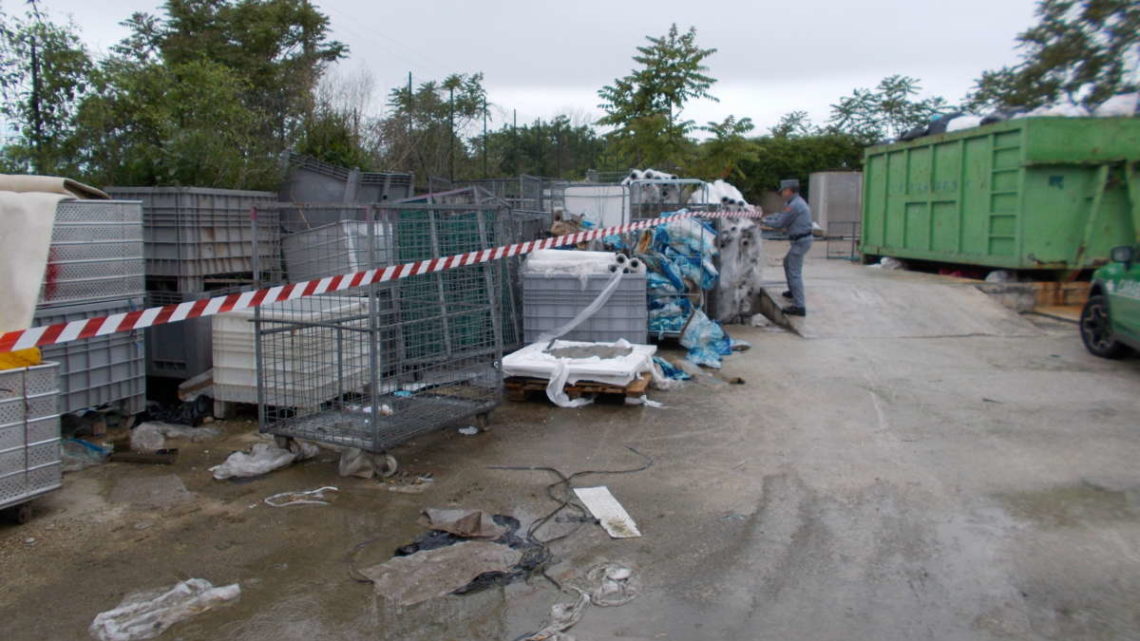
[[107, 187, 280, 278]]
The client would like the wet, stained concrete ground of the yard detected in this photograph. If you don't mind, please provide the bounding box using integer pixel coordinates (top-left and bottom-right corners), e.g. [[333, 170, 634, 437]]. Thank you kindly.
[[0, 244, 1140, 641]]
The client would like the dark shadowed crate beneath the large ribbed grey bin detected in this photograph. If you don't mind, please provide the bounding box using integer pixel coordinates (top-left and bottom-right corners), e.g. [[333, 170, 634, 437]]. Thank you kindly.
[[146, 292, 213, 380]]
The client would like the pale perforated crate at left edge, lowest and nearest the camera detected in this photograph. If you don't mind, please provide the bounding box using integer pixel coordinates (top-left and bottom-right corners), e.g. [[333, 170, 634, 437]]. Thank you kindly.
[[0, 363, 60, 510]]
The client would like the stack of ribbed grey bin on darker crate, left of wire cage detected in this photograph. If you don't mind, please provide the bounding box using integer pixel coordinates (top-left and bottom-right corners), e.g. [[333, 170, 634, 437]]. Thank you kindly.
[[107, 187, 280, 380]]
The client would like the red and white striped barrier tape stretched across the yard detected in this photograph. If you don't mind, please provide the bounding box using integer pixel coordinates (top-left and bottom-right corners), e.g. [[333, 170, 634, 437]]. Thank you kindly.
[[0, 210, 760, 354]]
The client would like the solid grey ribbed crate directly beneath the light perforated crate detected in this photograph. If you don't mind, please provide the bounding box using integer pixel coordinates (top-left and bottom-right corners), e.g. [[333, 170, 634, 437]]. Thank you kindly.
[[35, 297, 146, 414]]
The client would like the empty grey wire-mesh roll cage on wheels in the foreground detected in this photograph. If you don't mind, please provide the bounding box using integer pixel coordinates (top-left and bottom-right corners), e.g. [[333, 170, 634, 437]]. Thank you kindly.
[[252, 198, 510, 453]]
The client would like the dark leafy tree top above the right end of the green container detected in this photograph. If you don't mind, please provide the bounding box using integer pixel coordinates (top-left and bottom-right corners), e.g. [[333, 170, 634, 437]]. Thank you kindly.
[[967, 0, 1140, 109]]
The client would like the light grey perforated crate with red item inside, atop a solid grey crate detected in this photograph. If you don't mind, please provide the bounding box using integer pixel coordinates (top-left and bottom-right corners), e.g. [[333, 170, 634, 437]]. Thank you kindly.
[[40, 201, 145, 306]]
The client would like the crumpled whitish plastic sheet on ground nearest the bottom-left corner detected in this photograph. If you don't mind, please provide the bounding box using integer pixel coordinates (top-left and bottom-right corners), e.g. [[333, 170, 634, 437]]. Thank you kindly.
[[88, 578, 242, 641]]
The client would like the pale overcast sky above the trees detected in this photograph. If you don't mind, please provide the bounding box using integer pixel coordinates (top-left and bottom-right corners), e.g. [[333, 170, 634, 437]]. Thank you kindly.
[[26, 0, 1034, 131]]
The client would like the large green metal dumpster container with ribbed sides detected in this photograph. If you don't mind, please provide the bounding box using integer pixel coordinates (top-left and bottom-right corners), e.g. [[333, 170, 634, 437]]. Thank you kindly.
[[862, 117, 1140, 270]]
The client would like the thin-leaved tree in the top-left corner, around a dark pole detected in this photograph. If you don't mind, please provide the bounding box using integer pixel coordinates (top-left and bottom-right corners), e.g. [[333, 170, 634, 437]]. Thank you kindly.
[[0, 5, 92, 175]]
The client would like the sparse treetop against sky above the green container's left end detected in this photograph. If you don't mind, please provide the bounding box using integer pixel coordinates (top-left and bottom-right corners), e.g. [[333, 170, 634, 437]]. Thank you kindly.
[[829, 75, 950, 144]]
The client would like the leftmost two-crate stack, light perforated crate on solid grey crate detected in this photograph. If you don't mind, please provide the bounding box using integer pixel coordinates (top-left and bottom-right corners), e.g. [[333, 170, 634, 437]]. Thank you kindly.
[[34, 201, 146, 414]]
